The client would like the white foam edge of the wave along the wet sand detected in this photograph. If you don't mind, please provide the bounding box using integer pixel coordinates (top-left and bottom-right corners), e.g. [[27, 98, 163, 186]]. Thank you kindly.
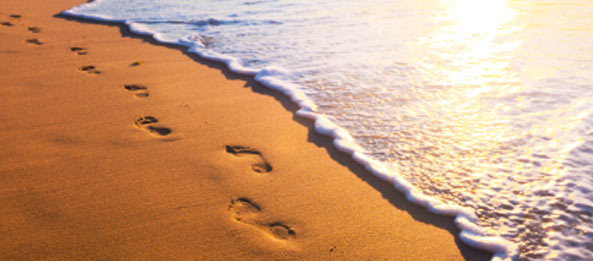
[[61, 5, 518, 260]]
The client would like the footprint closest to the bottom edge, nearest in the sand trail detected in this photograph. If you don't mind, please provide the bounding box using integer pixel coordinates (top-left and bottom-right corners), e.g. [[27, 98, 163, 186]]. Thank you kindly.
[[228, 198, 296, 240]]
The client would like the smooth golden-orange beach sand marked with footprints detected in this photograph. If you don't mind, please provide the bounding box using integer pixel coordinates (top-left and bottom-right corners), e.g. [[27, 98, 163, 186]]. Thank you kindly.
[[0, 0, 490, 260]]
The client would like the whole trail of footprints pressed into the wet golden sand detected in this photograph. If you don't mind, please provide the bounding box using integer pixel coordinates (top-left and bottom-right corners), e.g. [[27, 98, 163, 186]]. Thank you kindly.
[[0, 14, 296, 240]]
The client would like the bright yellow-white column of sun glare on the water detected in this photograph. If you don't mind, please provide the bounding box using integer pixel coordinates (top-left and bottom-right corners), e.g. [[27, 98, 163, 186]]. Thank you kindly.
[[404, 0, 524, 177]]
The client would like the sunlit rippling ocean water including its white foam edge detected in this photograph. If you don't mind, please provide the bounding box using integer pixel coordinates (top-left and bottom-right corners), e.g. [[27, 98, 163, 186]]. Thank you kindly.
[[64, 0, 593, 260]]
